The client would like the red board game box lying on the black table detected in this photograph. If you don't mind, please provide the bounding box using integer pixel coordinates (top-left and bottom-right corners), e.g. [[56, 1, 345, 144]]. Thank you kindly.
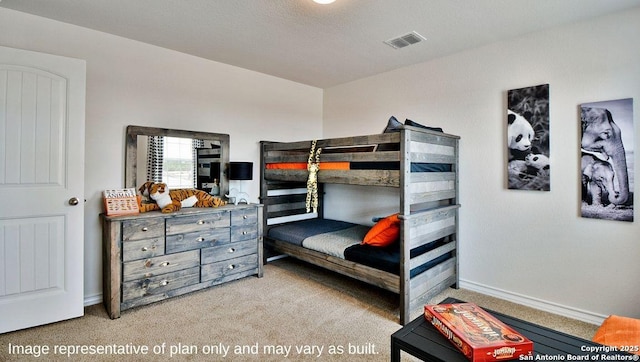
[[424, 303, 533, 362]]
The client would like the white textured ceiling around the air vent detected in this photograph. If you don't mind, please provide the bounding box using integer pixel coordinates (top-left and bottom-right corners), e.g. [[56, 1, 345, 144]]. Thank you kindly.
[[0, 0, 640, 88]]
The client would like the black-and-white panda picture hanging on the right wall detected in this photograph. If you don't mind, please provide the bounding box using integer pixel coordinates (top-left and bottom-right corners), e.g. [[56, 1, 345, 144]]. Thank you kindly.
[[507, 84, 551, 191]]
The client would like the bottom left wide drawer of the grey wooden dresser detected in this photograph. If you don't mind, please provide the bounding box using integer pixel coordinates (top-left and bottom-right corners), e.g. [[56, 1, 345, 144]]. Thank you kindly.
[[122, 267, 200, 302]]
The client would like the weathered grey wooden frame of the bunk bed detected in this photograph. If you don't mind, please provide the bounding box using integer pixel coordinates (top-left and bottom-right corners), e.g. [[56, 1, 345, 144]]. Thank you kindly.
[[260, 126, 460, 325]]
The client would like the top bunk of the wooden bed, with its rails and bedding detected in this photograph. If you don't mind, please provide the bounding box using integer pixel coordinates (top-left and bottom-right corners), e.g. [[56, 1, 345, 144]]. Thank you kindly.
[[262, 121, 459, 187]]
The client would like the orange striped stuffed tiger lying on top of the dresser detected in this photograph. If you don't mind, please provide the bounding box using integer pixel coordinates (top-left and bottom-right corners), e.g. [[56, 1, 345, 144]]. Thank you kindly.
[[141, 182, 227, 213]]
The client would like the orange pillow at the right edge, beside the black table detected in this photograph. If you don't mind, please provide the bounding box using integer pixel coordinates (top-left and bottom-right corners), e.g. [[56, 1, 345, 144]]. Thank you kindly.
[[593, 315, 640, 354]]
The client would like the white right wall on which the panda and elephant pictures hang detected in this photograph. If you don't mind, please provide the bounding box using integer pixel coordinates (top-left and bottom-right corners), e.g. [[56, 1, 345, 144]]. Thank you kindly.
[[323, 8, 640, 322]]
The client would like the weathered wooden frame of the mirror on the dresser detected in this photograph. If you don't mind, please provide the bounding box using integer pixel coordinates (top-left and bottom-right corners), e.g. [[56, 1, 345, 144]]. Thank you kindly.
[[124, 126, 229, 196]]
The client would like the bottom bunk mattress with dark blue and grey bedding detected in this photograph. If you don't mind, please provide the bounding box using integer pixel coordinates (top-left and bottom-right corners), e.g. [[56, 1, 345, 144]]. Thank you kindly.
[[268, 219, 451, 277]]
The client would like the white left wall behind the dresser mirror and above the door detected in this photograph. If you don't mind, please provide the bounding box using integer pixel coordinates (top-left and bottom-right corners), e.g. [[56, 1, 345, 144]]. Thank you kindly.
[[0, 8, 322, 303]]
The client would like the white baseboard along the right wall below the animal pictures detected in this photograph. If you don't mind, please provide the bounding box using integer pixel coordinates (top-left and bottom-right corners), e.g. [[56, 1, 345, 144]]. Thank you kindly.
[[459, 280, 607, 325]]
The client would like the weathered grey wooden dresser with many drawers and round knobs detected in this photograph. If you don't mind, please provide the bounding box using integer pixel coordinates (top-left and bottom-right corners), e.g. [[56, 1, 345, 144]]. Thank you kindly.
[[101, 204, 263, 319]]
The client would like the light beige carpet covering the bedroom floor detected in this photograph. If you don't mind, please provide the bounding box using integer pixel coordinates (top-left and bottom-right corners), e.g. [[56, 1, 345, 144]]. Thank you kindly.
[[0, 258, 597, 361]]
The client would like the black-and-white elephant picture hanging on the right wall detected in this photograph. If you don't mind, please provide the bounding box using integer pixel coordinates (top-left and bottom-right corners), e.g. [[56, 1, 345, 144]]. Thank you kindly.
[[580, 98, 634, 221]]
